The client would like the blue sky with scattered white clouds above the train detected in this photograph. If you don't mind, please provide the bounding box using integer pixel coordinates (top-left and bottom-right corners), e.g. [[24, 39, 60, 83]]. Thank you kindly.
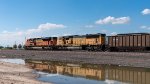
[[0, 0, 150, 45]]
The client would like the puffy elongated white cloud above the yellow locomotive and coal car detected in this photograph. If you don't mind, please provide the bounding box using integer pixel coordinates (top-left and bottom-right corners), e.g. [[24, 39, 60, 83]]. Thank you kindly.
[[95, 16, 130, 24]]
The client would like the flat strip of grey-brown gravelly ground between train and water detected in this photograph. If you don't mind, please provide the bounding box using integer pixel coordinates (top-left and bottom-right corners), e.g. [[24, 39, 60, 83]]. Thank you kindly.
[[0, 50, 150, 68]]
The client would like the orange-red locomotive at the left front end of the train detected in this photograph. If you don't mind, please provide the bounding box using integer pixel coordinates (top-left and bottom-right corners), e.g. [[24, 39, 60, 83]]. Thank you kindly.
[[25, 37, 57, 49]]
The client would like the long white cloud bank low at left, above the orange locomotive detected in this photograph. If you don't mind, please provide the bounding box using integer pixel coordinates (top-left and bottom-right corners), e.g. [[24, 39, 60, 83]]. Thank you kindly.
[[0, 23, 66, 46]]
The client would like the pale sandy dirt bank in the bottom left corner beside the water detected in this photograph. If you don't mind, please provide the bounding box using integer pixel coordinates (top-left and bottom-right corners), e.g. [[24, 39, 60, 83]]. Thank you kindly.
[[0, 62, 48, 84]]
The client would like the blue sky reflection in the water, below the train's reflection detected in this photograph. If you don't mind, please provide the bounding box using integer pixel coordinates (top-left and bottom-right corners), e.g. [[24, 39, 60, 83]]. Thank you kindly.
[[38, 73, 121, 84]]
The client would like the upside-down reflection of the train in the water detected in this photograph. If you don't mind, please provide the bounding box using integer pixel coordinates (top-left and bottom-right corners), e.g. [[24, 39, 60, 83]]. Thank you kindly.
[[25, 60, 150, 84]]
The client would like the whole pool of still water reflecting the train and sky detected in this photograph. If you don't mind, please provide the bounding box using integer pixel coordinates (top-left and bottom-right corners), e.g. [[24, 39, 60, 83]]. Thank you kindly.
[[0, 59, 150, 84]]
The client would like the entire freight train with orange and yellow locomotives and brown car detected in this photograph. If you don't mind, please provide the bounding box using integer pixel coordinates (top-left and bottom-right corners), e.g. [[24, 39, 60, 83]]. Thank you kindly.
[[25, 33, 150, 51]]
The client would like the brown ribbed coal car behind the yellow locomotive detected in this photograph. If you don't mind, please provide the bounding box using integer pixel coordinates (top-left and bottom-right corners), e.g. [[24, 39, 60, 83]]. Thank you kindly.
[[108, 33, 150, 51]]
